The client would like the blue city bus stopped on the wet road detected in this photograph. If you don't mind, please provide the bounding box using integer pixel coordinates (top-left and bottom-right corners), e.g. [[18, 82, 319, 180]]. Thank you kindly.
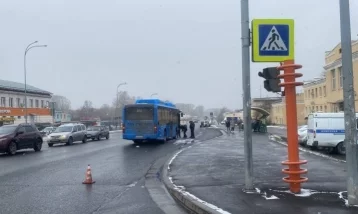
[[122, 99, 182, 143]]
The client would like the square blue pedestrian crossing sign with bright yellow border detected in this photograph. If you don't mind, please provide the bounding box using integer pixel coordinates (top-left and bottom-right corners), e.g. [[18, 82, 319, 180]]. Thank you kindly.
[[251, 19, 295, 62]]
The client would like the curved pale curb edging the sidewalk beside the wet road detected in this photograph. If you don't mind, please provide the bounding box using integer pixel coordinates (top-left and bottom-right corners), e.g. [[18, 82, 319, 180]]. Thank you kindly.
[[162, 129, 227, 214]]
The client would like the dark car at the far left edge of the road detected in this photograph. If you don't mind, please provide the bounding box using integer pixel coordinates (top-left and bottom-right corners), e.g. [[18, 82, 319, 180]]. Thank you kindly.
[[0, 124, 42, 155]]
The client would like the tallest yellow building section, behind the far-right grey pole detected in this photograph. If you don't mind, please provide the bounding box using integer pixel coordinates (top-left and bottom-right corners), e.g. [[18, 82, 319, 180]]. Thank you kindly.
[[324, 40, 358, 112]]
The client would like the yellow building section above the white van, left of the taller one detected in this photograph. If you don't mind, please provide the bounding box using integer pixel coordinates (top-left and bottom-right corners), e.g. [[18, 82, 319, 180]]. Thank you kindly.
[[303, 78, 331, 116]]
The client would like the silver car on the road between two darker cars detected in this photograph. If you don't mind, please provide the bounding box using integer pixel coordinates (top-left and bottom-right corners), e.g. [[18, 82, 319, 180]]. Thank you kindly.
[[47, 123, 87, 147]]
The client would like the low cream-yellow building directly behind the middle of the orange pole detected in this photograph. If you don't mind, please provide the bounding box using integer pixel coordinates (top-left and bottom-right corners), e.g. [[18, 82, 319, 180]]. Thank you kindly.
[[269, 93, 306, 125]]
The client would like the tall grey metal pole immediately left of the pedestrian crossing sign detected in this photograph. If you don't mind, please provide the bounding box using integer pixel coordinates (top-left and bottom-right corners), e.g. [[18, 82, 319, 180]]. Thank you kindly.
[[241, 0, 253, 190]]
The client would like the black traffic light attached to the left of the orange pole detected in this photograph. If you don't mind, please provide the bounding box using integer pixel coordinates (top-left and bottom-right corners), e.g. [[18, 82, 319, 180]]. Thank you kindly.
[[258, 67, 281, 92]]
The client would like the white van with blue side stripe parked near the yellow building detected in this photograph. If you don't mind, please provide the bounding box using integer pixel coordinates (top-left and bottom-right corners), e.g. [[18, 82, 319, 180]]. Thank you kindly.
[[307, 113, 358, 154]]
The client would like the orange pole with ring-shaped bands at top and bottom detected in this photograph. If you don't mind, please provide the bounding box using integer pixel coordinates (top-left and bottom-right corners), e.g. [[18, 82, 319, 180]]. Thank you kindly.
[[278, 60, 308, 193]]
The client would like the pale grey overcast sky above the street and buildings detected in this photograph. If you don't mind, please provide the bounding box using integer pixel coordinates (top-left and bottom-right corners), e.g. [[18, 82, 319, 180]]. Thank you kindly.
[[0, 0, 358, 108]]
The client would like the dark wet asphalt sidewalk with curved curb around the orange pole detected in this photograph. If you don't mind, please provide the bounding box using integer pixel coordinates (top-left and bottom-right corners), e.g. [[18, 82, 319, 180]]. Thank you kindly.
[[164, 132, 358, 214]]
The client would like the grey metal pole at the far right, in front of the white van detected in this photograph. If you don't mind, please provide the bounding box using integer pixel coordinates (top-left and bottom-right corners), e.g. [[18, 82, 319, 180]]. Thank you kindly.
[[339, 0, 358, 205]]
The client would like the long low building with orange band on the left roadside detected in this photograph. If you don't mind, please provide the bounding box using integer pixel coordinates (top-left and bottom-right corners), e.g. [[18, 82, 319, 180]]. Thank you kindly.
[[0, 80, 52, 125]]
